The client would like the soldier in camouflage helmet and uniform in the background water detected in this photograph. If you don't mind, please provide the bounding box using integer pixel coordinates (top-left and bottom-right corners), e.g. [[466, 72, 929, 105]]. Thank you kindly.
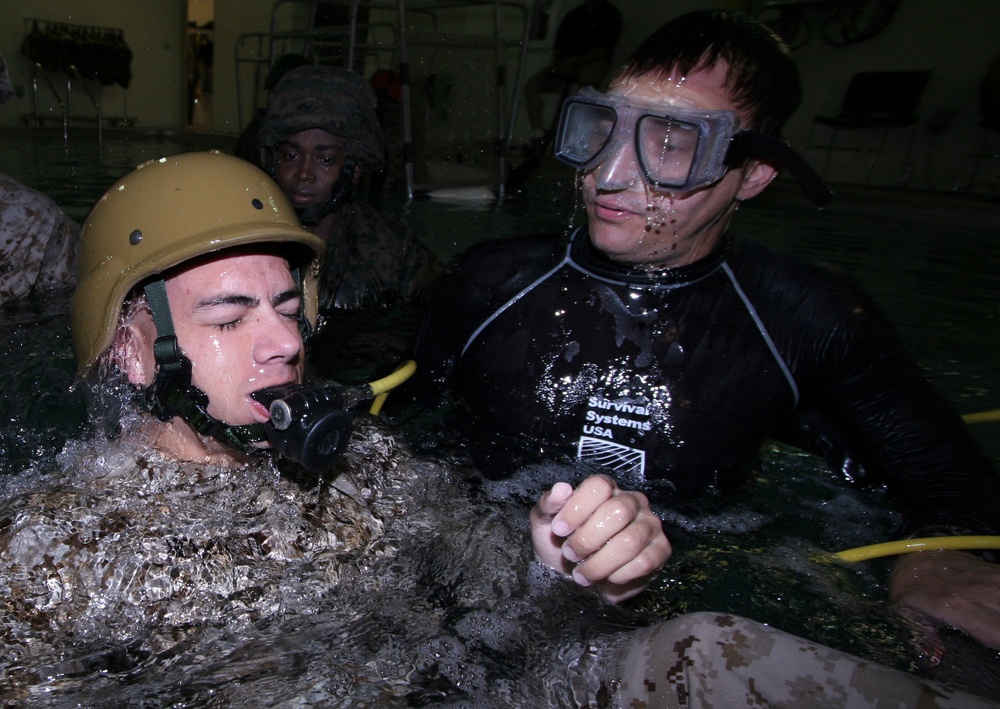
[[258, 66, 439, 310]]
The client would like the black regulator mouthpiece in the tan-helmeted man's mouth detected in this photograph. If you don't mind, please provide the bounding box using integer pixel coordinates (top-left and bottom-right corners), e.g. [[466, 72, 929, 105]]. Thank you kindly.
[[251, 384, 352, 472]]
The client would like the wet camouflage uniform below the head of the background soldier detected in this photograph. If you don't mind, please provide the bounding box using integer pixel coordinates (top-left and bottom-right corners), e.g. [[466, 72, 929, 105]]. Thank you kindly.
[[320, 200, 441, 310]]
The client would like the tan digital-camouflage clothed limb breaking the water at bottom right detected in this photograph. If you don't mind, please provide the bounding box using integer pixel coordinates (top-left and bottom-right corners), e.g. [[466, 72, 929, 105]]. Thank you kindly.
[[610, 613, 997, 709]]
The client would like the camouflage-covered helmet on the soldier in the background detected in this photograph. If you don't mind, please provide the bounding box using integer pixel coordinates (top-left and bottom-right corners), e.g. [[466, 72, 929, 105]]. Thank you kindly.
[[257, 66, 385, 172]]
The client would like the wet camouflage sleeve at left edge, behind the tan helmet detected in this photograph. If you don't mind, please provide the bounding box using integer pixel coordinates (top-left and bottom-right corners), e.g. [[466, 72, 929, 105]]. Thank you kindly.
[[0, 174, 80, 304]]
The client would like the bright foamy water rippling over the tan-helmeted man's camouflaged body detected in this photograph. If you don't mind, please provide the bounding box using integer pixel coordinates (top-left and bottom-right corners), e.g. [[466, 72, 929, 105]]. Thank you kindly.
[[0, 422, 656, 707]]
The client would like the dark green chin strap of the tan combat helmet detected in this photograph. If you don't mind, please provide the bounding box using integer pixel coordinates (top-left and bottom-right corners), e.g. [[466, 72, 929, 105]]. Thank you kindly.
[[145, 280, 267, 453]]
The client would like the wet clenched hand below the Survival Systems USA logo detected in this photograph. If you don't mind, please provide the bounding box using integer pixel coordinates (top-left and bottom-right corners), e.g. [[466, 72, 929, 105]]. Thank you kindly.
[[531, 475, 671, 603]]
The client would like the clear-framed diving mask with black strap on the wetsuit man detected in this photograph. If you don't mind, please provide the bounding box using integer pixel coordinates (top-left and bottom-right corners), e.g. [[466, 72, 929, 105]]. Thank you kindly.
[[555, 87, 832, 207]]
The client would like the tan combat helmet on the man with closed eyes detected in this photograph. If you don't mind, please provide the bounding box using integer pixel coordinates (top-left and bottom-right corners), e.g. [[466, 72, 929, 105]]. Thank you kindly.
[[71, 152, 326, 376]]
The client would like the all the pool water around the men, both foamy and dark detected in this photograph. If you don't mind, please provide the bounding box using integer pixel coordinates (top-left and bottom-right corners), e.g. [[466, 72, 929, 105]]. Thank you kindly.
[[0, 129, 1000, 706]]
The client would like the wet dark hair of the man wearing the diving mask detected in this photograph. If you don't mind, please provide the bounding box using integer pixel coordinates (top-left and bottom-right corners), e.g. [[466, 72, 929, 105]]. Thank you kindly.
[[616, 10, 802, 135]]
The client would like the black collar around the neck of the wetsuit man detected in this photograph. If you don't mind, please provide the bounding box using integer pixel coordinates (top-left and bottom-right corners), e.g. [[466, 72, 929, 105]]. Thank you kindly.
[[566, 226, 733, 288]]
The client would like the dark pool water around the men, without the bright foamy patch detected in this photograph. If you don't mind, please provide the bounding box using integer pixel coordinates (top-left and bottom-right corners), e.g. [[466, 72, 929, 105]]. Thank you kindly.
[[0, 131, 1000, 699]]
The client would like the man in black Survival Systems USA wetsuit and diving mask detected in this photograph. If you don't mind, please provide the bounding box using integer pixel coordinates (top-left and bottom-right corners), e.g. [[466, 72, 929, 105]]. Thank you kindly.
[[416, 11, 1000, 648]]
